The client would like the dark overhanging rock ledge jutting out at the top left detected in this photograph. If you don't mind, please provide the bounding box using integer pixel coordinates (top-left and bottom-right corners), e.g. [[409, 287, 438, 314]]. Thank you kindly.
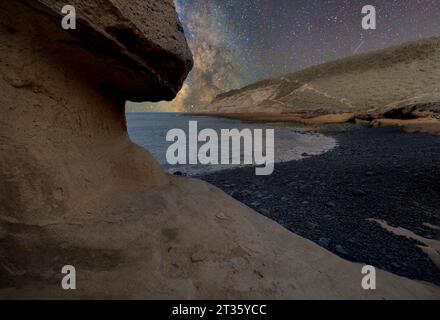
[[22, 0, 193, 102]]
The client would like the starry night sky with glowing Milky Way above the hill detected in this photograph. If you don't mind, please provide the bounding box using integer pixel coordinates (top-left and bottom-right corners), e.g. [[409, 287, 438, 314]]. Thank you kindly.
[[127, 0, 440, 111]]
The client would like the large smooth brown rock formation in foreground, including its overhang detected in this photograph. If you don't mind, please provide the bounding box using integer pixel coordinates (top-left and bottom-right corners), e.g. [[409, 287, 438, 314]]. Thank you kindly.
[[0, 0, 439, 298]]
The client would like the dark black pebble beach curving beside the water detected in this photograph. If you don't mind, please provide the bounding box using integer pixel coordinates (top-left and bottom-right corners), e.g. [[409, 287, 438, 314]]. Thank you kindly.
[[201, 124, 440, 285]]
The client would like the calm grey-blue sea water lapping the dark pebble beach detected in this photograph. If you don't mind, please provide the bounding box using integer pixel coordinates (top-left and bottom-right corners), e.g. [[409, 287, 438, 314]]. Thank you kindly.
[[126, 113, 336, 175]]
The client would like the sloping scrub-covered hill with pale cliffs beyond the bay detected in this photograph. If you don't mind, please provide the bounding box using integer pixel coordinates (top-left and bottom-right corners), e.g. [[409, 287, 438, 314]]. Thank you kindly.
[[208, 37, 440, 132]]
